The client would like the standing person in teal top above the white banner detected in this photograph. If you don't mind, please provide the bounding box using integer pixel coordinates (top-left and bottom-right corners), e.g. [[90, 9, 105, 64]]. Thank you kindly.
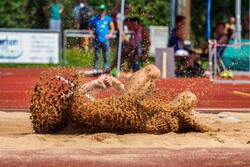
[[44, 0, 64, 31]]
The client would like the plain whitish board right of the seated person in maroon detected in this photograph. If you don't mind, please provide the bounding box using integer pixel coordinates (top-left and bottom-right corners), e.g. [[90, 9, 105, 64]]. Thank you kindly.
[[149, 26, 169, 56]]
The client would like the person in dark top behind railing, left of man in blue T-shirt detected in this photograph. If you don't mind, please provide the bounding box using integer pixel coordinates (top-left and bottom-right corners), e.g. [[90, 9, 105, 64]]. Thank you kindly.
[[77, 0, 94, 50]]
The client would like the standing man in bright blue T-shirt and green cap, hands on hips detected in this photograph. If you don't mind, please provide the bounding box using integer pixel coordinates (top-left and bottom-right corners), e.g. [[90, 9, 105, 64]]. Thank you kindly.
[[89, 5, 114, 74]]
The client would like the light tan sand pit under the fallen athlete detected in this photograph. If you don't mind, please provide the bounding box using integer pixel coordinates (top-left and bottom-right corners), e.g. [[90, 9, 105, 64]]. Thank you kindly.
[[0, 112, 250, 150]]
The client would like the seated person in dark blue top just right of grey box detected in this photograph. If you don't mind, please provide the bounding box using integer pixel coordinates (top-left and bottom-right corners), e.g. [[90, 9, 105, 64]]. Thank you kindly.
[[168, 16, 203, 75]]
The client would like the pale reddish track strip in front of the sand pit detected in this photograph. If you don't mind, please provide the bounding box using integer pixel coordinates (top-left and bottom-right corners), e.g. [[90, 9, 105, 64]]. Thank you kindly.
[[0, 148, 250, 167]]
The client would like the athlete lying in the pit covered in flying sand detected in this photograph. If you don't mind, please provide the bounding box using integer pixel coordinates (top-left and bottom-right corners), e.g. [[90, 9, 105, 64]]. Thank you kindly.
[[30, 64, 210, 133]]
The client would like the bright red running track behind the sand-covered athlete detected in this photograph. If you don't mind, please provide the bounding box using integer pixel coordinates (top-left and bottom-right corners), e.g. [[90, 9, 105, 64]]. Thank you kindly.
[[0, 68, 250, 111]]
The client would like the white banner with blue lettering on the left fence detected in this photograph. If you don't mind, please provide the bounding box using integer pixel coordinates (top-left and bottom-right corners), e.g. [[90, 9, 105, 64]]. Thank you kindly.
[[0, 31, 60, 64]]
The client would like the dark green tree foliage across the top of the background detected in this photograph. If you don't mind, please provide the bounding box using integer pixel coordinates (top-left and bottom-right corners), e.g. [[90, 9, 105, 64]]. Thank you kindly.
[[0, 0, 249, 46]]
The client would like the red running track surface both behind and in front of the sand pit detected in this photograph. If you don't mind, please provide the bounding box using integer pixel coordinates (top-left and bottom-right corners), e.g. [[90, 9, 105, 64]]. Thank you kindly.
[[0, 68, 250, 167]]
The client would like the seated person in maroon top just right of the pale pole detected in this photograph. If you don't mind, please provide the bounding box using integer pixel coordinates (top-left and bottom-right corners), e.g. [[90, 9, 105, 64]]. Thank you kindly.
[[110, 17, 150, 72]]
